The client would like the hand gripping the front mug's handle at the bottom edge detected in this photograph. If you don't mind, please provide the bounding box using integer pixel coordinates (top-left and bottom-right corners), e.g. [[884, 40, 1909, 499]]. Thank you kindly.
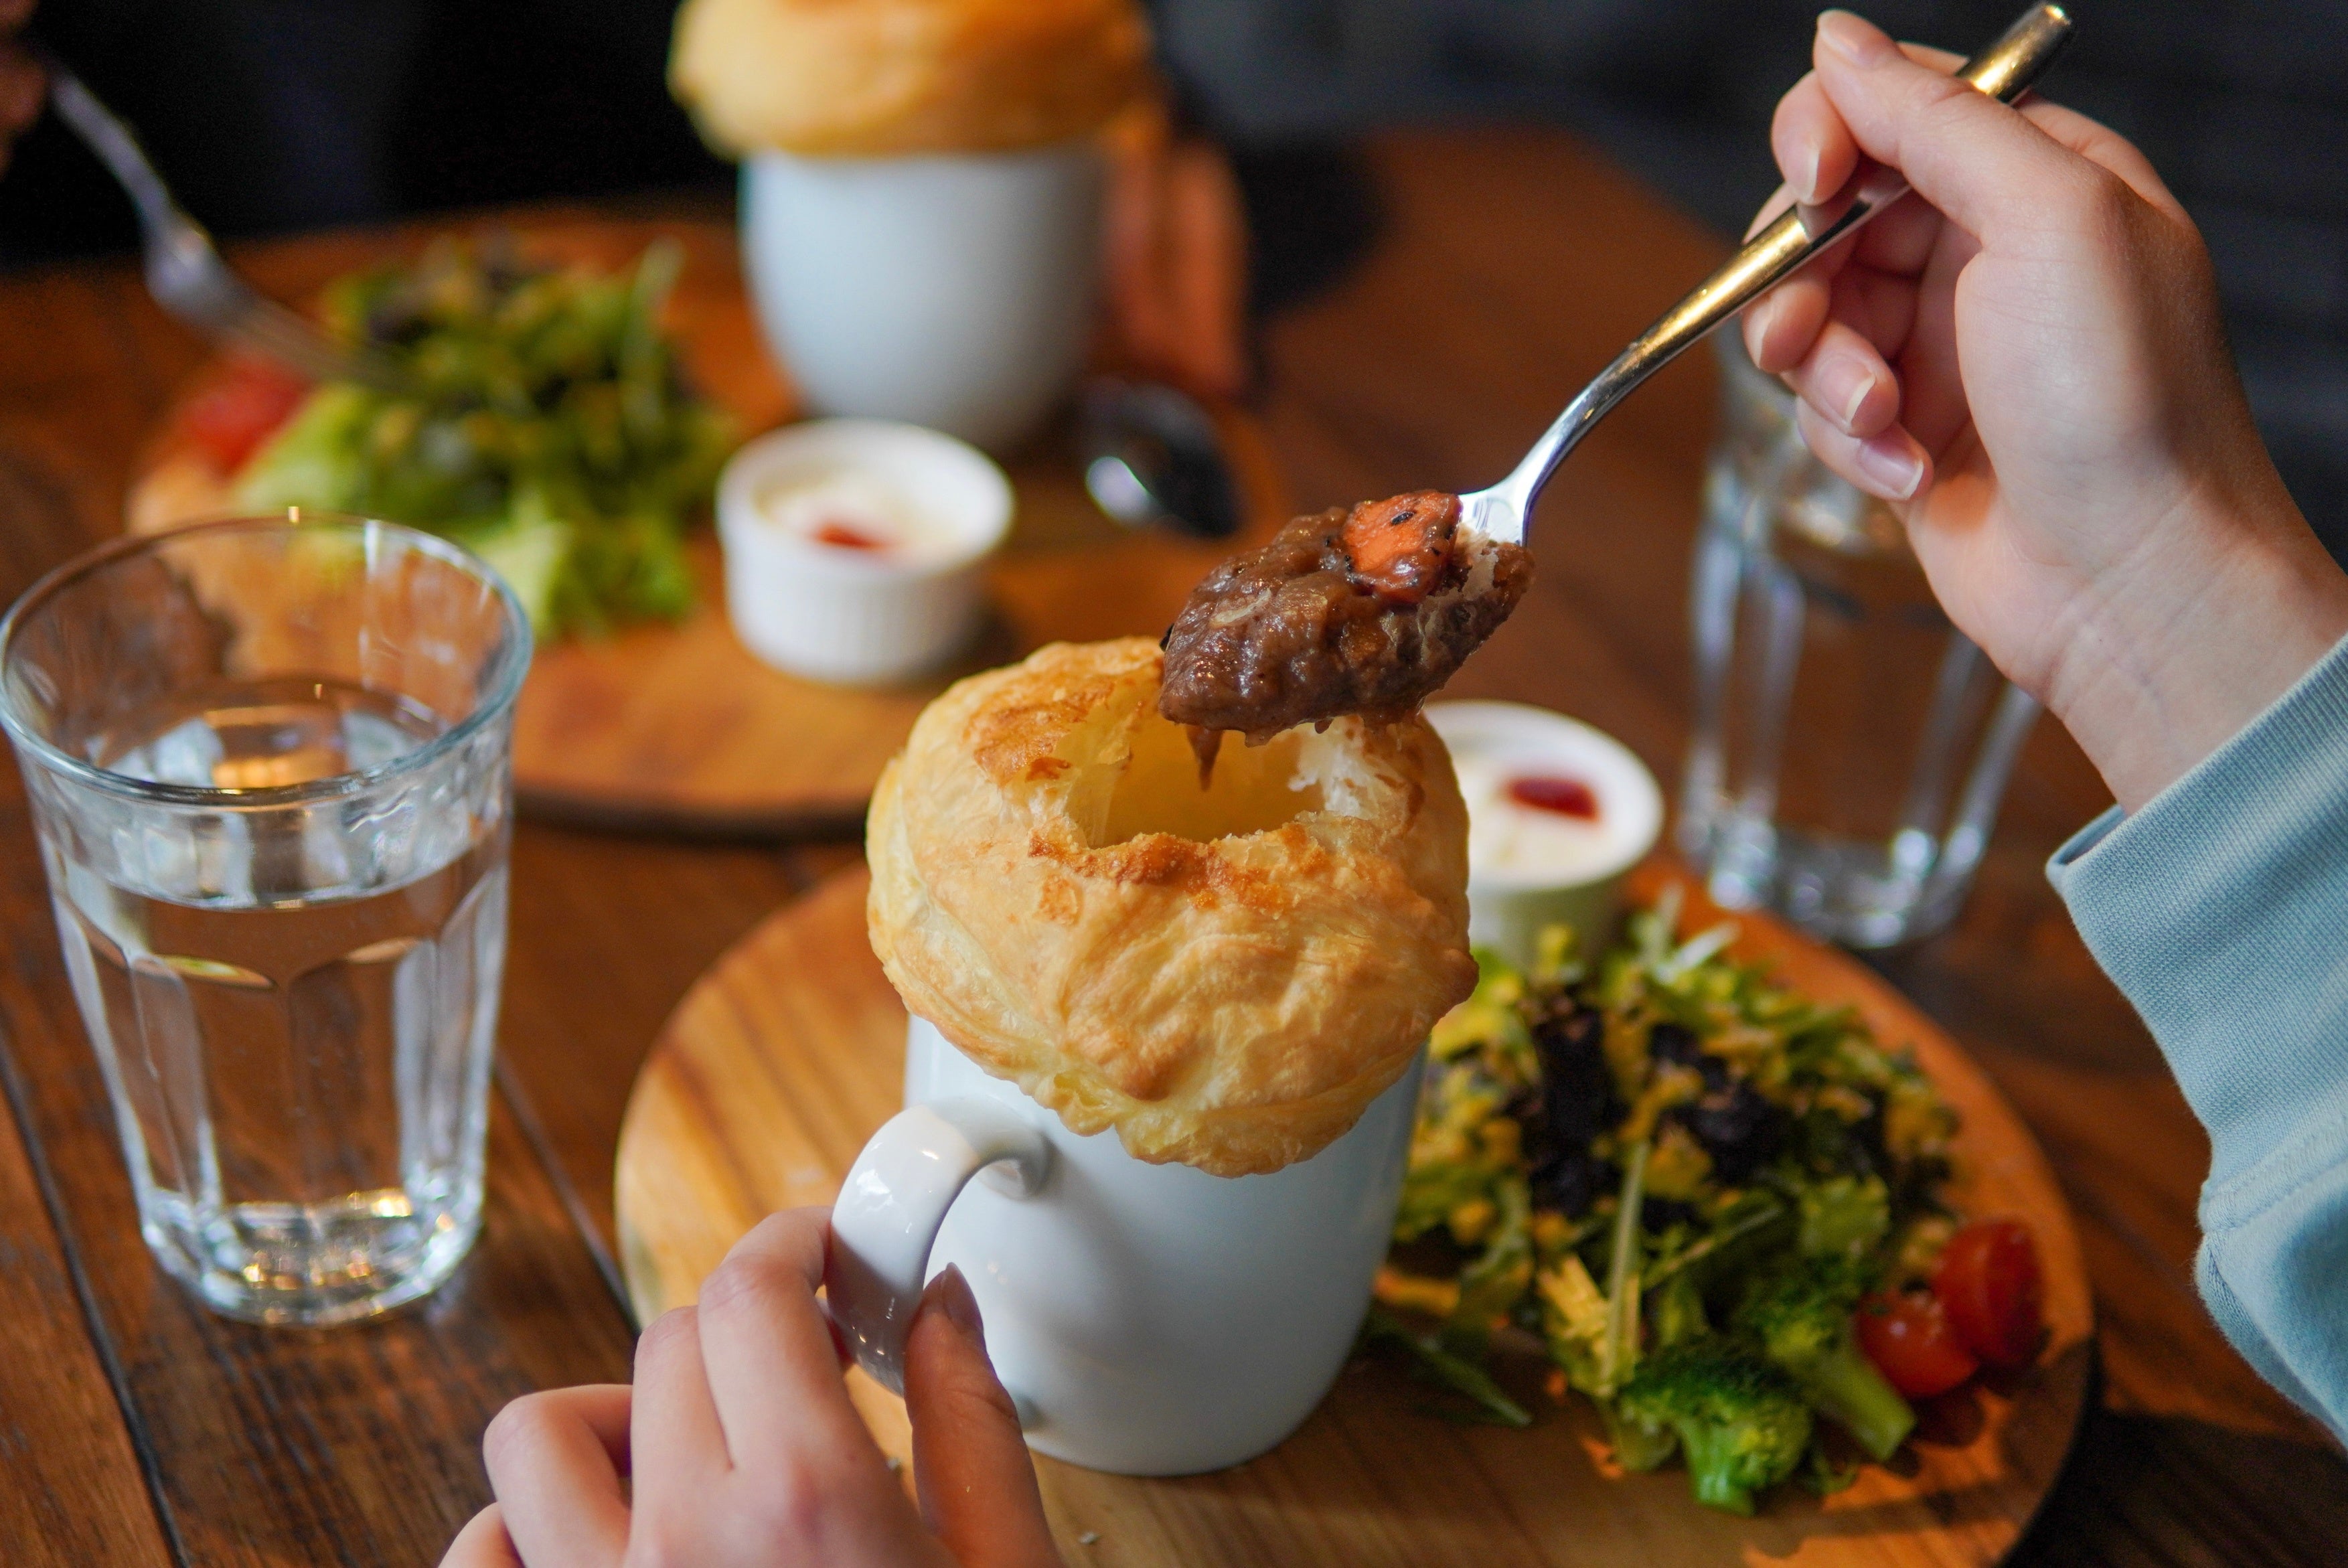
[[441, 1209, 1061, 1568]]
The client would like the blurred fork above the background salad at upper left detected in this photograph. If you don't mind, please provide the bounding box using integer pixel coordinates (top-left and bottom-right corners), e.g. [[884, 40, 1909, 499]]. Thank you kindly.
[[42, 56, 408, 392]]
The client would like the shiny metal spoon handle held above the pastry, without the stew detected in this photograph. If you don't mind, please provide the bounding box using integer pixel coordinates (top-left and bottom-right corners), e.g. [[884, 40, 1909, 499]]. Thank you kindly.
[[1460, 5, 2071, 544]]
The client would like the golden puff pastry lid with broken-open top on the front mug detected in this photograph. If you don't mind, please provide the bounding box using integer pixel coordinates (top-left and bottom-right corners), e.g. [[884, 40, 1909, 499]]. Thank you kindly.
[[866, 639, 1474, 1176]]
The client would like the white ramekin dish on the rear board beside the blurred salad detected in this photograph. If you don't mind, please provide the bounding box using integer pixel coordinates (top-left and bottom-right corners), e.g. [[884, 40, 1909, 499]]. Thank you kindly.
[[716, 420, 1014, 686]]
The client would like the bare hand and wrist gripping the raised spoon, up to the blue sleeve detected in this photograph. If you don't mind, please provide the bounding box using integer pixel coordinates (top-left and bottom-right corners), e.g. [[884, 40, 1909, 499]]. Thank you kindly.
[[1745, 12, 2348, 807]]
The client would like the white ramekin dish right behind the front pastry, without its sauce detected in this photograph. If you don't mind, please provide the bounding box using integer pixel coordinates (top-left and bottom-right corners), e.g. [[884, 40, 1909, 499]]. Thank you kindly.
[[1427, 702, 1662, 965]]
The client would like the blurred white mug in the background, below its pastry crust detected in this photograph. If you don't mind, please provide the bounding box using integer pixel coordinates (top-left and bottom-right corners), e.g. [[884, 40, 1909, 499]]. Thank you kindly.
[[742, 139, 1106, 451]]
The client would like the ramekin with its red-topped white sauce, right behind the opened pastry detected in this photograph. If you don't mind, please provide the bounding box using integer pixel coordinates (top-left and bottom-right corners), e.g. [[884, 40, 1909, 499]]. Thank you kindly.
[[1427, 702, 1662, 965]]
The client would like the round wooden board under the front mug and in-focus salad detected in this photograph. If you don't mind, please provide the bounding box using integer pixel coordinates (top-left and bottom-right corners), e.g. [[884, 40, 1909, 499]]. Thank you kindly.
[[617, 866, 2092, 1568]]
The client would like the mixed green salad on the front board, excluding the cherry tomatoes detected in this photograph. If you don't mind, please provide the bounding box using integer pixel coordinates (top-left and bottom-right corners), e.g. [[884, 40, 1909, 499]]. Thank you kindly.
[[1369, 890, 2038, 1512]]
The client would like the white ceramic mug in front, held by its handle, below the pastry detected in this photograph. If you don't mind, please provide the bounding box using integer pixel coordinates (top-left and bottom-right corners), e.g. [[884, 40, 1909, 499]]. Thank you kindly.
[[826, 1019, 1421, 1476]]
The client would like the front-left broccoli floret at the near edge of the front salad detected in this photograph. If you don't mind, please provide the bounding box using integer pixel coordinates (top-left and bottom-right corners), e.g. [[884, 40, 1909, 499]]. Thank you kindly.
[[1616, 1338, 1810, 1514]]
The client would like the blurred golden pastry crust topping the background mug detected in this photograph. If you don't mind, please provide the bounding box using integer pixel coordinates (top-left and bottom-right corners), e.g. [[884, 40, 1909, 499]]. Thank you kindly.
[[669, 0, 1150, 157]]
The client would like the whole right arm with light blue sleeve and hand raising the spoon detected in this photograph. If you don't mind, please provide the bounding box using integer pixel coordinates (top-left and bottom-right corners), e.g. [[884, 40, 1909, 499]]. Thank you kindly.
[[1745, 12, 2348, 1434]]
